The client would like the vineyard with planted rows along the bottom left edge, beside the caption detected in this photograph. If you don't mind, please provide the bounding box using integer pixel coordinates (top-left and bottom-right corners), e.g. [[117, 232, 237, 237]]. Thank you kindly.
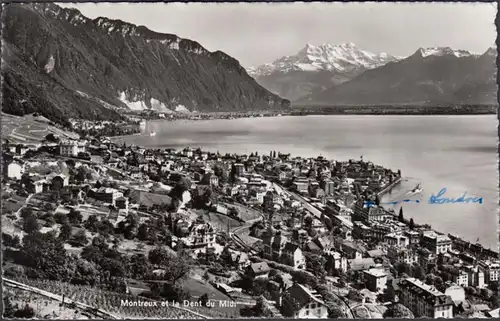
[[6, 278, 231, 319]]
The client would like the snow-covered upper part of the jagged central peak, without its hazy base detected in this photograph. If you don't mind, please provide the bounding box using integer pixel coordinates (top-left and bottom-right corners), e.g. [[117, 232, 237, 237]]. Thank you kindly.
[[247, 43, 398, 77]]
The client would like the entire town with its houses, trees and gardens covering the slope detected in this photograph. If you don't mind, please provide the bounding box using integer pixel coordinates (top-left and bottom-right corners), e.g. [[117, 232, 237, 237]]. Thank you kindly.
[[2, 117, 500, 318]]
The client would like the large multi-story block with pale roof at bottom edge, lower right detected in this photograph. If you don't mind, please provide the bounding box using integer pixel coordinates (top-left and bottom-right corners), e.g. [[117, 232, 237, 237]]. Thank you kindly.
[[399, 278, 453, 319]]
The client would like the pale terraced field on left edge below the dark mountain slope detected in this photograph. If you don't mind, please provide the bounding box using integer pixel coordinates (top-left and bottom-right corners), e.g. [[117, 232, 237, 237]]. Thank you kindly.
[[2, 113, 78, 144]]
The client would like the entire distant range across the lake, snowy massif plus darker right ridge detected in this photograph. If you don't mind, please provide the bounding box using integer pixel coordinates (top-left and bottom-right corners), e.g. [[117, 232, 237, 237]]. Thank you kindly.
[[247, 43, 497, 105]]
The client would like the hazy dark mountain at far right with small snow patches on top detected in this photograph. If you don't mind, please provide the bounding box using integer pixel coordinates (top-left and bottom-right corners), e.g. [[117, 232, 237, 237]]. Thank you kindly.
[[297, 48, 497, 105]]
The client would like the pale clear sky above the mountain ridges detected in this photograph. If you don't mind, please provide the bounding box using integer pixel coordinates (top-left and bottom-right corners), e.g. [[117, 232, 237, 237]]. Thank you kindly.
[[58, 2, 497, 67]]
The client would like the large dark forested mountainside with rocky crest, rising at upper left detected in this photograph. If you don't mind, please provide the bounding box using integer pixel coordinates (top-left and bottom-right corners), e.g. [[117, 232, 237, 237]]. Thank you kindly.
[[2, 3, 290, 122]]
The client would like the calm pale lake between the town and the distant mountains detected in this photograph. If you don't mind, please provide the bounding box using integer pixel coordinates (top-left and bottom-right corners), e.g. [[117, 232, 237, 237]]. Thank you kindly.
[[116, 115, 499, 251]]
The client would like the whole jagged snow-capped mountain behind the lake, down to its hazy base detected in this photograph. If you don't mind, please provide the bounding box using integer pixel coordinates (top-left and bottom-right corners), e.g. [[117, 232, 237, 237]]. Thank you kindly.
[[247, 43, 401, 100]]
